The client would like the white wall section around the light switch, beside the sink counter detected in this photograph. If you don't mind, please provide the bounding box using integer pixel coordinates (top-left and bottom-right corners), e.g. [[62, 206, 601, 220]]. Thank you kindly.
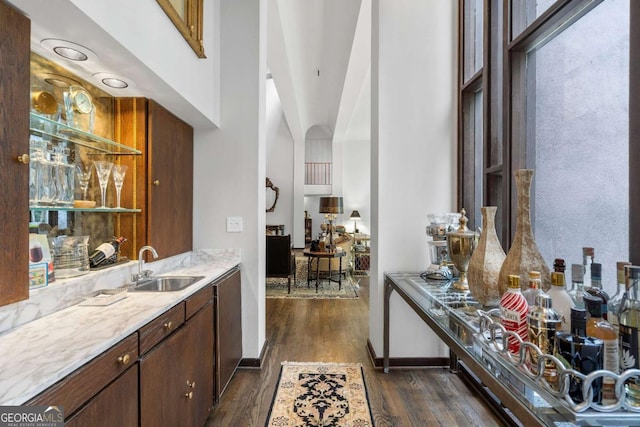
[[193, 0, 266, 358]]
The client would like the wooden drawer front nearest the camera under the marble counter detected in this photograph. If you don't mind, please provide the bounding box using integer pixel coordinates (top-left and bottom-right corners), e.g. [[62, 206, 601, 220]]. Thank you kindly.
[[27, 334, 138, 417]]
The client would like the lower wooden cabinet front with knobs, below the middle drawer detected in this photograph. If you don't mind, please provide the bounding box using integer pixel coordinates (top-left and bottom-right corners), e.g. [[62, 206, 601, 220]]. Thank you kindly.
[[140, 303, 213, 427]]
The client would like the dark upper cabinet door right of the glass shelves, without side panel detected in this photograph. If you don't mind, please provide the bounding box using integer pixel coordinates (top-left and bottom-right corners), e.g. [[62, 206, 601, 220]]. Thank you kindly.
[[147, 101, 193, 257]]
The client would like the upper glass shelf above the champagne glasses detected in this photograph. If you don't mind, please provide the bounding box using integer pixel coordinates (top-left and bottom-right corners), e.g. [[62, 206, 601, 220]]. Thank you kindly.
[[29, 113, 142, 155]]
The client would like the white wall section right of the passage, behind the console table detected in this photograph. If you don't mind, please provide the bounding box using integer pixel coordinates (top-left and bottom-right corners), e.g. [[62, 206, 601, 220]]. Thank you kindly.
[[369, 0, 457, 357]]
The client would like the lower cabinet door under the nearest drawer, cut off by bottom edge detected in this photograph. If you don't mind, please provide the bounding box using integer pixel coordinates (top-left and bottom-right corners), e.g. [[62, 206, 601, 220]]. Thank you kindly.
[[65, 363, 138, 427]]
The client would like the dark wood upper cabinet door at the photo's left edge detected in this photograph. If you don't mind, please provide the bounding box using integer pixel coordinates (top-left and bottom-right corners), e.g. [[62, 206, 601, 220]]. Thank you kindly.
[[0, 1, 31, 305]]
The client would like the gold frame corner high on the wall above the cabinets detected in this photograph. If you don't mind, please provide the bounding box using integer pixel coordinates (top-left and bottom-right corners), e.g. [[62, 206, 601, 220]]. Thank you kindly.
[[156, 0, 205, 58]]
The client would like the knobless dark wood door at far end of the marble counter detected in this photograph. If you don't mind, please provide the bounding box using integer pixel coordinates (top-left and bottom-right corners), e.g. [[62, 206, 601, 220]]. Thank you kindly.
[[214, 271, 242, 401]]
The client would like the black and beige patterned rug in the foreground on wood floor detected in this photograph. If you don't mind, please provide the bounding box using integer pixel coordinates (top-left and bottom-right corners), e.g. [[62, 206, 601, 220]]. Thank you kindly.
[[265, 362, 374, 427]]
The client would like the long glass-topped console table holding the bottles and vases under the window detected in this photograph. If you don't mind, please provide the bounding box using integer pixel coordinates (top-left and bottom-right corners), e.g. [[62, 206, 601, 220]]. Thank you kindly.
[[383, 272, 640, 427]]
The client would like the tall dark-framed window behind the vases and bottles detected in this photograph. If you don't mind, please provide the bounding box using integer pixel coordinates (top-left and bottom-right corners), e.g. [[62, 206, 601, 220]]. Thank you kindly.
[[459, 0, 640, 290]]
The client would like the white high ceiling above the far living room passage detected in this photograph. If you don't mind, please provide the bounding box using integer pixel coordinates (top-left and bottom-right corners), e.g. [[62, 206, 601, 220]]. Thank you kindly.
[[267, 0, 371, 141]]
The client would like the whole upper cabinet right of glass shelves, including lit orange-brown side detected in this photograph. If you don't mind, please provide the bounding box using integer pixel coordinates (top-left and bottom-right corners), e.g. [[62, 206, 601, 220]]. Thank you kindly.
[[115, 98, 193, 259]]
